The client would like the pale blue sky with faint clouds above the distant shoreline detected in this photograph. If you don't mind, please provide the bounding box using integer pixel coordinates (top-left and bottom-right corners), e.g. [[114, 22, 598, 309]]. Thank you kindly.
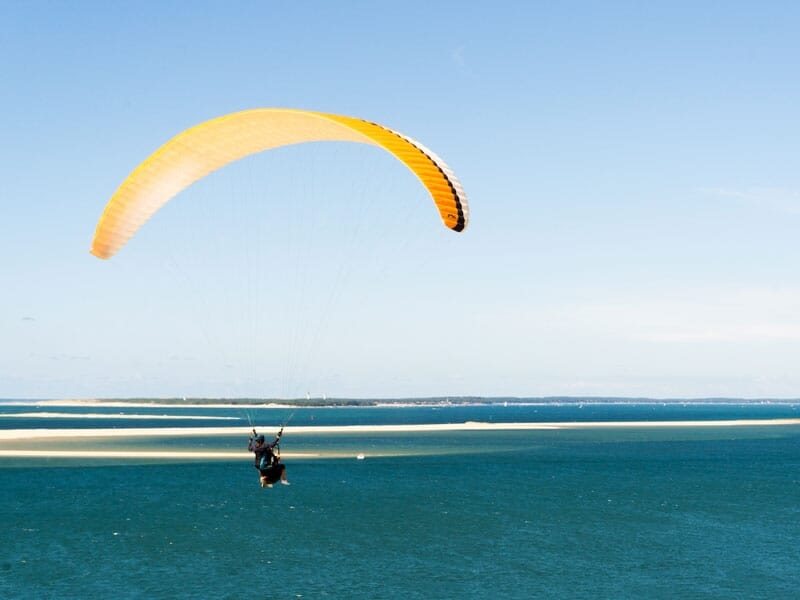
[[0, 0, 800, 398]]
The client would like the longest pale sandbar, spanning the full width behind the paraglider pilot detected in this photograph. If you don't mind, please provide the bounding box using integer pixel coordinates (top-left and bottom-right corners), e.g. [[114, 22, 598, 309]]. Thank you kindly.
[[0, 419, 800, 441]]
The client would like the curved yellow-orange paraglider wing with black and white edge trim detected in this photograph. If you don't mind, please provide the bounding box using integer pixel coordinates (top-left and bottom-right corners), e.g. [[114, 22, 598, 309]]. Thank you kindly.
[[91, 108, 469, 258]]
